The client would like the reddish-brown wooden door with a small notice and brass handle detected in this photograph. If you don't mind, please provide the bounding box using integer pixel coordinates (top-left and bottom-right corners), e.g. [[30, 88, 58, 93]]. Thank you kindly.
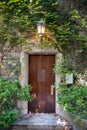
[[29, 55, 55, 113]]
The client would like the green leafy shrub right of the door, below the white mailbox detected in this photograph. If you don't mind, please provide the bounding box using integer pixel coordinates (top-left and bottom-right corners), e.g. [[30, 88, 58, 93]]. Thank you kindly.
[[58, 85, 87, 118]]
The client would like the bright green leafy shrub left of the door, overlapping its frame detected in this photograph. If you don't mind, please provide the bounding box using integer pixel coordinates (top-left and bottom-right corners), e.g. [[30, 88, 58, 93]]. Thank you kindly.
[[0, 79, 32, 129]]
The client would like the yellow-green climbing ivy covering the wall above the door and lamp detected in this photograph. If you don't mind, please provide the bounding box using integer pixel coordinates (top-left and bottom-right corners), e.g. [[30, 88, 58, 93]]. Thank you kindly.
[[0, 0, 87, 51]]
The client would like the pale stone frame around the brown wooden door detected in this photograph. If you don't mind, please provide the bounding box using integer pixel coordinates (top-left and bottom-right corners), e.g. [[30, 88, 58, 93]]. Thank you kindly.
[[19, 50, 61, 114]]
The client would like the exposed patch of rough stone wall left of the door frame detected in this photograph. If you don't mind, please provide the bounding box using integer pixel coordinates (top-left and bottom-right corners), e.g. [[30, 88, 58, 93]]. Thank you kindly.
[[1, 47, 21, 80]]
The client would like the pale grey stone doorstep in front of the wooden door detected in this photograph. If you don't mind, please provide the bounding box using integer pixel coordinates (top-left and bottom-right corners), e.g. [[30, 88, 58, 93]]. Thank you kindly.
[[12, 113, 72, 130]]
